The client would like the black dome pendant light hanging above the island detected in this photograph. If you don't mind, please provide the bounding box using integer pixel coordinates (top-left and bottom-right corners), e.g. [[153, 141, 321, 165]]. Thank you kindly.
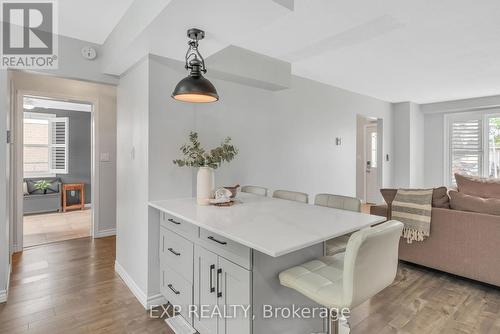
[[172, 28, 219, 103]]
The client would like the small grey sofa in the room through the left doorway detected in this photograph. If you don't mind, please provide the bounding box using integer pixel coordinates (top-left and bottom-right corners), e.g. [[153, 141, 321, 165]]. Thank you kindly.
[[23, 178, 61, 215]]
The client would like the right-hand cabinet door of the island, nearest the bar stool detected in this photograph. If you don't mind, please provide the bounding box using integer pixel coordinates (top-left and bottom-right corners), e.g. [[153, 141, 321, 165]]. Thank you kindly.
[[217, 257, 253, 334]]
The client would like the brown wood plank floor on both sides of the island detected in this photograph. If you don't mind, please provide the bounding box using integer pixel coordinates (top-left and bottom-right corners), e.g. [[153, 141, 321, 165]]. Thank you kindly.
[[0, 237, 500, 334]]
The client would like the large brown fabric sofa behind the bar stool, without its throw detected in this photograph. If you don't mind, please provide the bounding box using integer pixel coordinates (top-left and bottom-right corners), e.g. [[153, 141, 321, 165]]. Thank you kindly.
[[370, 177, 500, 286]]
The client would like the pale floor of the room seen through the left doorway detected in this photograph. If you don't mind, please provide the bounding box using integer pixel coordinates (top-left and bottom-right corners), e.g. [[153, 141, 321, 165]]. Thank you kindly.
[[23, 209, 92, 247]]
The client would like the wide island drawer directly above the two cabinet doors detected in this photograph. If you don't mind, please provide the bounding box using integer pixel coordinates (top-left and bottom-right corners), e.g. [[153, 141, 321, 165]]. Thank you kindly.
[[200, 228, 252, 270]]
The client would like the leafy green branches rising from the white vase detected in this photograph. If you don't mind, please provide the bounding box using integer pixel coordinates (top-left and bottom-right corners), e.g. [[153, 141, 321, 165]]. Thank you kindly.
[[174, 132, 238, 169]]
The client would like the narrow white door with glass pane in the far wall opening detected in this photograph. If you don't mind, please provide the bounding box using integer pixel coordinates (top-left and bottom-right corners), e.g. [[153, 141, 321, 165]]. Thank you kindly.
[[365, 124, 379, 203]]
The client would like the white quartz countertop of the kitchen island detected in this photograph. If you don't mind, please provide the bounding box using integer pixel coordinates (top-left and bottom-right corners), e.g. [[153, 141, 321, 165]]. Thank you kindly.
[[149, 193, 385, 257]]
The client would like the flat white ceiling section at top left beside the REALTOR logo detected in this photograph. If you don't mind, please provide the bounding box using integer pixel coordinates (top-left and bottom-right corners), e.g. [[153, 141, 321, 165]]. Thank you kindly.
[[57, 0, 135, 44]]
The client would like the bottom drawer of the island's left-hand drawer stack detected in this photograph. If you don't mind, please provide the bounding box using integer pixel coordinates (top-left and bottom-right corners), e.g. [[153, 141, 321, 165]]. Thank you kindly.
[[161, 266, 193, 323]]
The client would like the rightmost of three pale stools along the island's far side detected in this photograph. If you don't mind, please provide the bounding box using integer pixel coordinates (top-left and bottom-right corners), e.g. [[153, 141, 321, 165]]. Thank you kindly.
[[314, 194, 361, 255]]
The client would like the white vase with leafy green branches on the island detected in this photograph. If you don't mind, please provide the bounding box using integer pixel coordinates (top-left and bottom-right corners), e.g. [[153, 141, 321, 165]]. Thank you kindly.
[[174, 132, 238, 205]]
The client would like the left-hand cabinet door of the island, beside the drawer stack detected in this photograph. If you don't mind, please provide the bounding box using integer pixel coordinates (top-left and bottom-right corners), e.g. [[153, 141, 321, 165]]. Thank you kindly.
[[194, 245, 218, 334]]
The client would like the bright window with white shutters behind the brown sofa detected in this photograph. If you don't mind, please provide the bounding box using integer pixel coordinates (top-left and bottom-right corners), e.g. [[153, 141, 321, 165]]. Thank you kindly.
[[445, 112, 500, 185]]
